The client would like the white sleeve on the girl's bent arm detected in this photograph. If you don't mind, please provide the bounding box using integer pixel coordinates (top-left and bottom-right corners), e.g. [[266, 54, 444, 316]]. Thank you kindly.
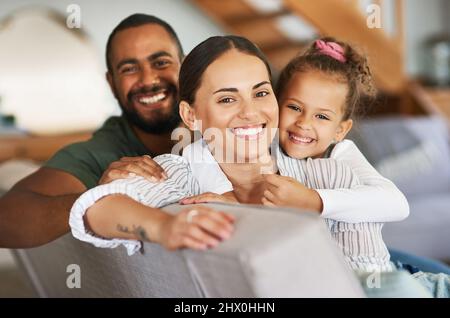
[[316, 140, 409, 223]]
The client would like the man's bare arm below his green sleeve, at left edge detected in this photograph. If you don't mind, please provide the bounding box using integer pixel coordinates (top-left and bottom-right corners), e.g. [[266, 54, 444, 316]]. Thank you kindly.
[[0, 168, 86, 248]]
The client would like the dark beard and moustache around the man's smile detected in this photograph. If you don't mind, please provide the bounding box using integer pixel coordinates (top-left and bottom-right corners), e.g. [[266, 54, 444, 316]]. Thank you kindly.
[[119, 84, 181, 135]]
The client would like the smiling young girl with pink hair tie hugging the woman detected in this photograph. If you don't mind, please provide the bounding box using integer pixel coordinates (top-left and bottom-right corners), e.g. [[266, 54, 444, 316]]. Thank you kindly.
[[262, 38, 398, 271]]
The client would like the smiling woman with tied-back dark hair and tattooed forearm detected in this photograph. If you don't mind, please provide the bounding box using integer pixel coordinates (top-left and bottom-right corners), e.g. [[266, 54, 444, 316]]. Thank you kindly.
[[70, 36, 278, 254]]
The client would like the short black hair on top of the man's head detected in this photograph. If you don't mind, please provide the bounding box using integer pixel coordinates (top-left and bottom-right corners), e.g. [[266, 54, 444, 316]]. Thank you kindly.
[[106, 13, 184, 73]]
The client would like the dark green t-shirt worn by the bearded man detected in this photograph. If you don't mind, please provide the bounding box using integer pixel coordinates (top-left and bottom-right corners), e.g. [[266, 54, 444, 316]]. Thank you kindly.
[[44, 117, 152, 189]]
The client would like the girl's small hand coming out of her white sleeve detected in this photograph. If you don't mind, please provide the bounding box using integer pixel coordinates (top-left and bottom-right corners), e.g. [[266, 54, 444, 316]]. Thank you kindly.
[[261, 174, 323, 213]]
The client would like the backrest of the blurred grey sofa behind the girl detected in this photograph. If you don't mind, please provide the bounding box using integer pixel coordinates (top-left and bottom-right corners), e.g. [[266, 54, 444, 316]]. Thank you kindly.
[[348, 116, 450, 199]]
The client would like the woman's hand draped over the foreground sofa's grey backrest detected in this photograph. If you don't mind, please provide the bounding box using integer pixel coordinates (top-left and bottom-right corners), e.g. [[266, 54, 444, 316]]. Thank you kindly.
[[155, 206, 235, 250]]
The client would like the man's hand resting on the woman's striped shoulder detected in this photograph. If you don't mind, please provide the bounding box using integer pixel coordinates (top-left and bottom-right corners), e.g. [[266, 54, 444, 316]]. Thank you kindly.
[[98, 155, 167, 184]]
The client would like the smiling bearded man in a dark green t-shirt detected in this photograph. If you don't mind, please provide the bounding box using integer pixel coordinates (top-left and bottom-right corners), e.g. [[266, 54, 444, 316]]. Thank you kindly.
[[0, 14, 183, 248]]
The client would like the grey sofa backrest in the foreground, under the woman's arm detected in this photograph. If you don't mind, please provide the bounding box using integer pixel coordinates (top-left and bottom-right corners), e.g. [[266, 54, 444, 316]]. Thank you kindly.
[[16, 204, 364, 297]]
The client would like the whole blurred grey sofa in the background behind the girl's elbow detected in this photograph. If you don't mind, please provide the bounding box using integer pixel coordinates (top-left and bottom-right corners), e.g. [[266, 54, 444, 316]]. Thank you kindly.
[[350, 117, 450, 261]]
